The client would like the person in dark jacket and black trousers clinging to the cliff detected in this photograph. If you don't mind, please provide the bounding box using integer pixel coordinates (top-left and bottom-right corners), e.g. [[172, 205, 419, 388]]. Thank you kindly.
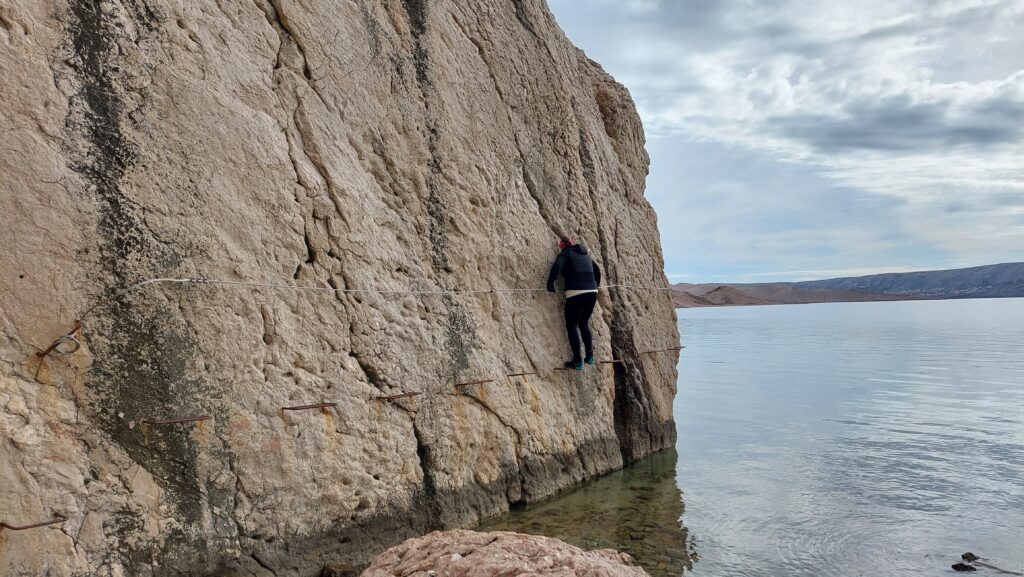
[[548, 237, 601, 371]]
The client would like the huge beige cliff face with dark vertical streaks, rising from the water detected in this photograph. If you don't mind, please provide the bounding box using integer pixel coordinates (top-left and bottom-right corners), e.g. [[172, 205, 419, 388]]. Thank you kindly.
[[0, 0, 678, 576]]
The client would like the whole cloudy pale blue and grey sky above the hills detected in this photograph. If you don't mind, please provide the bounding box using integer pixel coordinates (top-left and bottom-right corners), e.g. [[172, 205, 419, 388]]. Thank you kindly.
[[549, 0, 1024, 282]]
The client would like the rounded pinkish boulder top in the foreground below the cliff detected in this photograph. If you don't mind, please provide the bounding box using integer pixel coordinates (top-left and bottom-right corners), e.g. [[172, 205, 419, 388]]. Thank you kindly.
[[361, 531, 647, 577]]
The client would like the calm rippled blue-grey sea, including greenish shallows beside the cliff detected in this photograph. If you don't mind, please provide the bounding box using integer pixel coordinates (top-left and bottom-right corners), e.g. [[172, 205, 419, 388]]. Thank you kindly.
[[485, 299, 1024, 577]]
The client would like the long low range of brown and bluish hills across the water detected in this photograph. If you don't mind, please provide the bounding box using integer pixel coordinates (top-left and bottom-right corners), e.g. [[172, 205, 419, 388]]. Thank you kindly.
[[673, 262, 1024, 307]]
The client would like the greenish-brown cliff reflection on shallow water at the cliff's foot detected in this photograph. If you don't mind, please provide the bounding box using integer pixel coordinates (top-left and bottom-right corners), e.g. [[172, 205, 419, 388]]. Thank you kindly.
[[479, 450, 697, 577]]
